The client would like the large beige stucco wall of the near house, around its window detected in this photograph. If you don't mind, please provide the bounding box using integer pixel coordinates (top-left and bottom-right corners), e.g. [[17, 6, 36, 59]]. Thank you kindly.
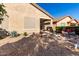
[[1, 3, 51, 33]]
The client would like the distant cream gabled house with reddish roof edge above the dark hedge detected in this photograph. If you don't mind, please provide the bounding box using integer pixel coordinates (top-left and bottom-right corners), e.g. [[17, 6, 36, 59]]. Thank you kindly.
[[56, 16, 78, 26]]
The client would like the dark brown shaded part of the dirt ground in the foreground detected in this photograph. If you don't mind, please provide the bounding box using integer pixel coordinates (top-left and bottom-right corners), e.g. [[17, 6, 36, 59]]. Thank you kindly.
[[0, 34, 79, 56]]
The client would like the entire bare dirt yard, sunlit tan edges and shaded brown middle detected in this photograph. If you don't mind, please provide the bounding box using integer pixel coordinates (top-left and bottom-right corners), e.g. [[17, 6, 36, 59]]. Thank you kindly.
[[0, 34, 79, 56]]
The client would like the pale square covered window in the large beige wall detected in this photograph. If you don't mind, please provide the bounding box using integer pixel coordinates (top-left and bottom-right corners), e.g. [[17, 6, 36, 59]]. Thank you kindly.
[[24, 17, 35, 29]]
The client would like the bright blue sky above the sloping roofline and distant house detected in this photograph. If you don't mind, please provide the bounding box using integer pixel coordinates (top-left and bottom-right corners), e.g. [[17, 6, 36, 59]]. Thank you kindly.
[[37, 3, 79, 20]]
